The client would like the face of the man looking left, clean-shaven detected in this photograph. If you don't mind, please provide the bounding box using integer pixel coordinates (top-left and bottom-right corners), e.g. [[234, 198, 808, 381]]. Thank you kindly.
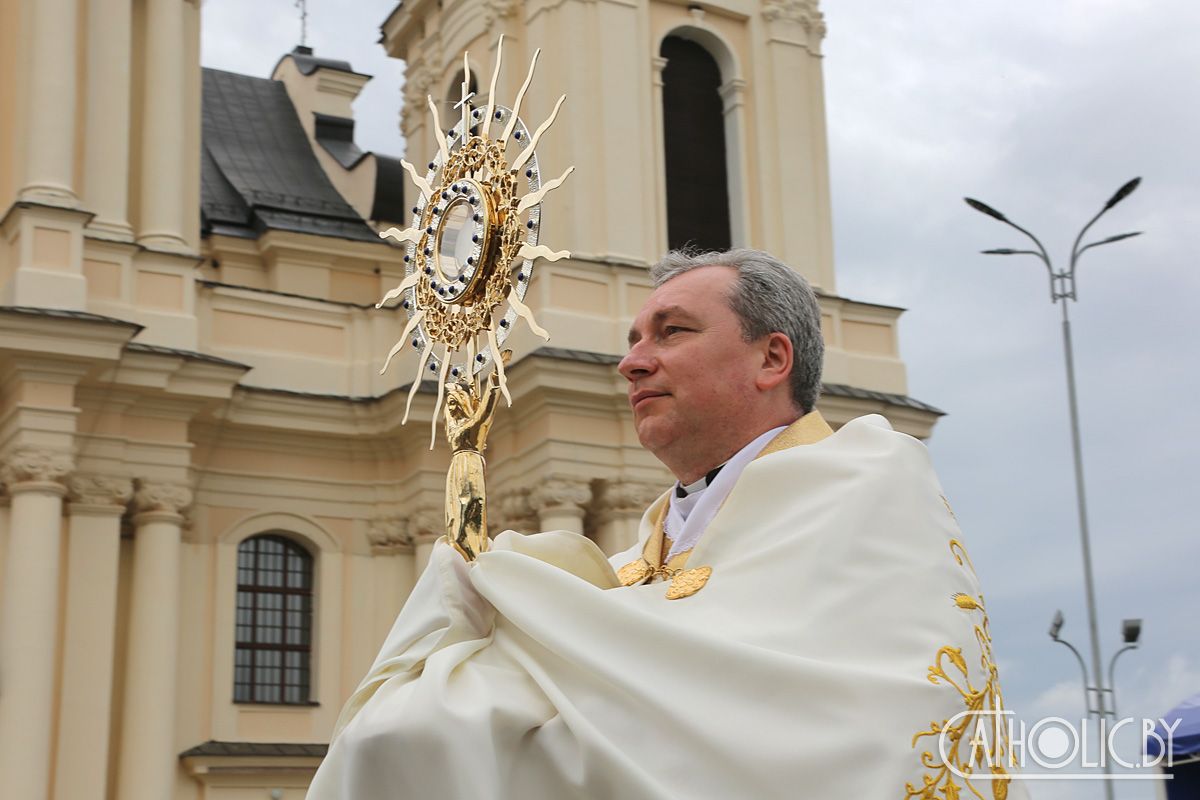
[[618, 266, 762, 480]]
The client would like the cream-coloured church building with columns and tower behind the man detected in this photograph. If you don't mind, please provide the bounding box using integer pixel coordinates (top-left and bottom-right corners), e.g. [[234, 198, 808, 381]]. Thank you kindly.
[[0, 0, 941, 800]]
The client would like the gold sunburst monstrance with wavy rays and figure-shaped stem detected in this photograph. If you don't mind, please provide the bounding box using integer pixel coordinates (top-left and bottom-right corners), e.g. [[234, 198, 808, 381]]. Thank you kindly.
[[376, 36, 575, 560]]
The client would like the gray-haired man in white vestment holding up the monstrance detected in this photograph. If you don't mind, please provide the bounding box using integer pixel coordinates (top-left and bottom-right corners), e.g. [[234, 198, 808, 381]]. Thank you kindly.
[[308, 251, 1016, 800]]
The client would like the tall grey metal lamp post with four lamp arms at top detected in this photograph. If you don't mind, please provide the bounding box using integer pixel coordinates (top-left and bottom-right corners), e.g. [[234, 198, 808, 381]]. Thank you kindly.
[[962, 178, 1141, 799]]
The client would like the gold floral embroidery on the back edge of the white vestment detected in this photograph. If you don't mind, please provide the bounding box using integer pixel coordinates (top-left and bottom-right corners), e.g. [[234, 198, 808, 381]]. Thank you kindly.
[[905, 537, 1014, 800]]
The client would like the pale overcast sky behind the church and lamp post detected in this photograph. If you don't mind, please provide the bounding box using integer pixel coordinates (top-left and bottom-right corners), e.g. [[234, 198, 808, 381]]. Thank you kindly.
[[203, 0, 1200, 800]]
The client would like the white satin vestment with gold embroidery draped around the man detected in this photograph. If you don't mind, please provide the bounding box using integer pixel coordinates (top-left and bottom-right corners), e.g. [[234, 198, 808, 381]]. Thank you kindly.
[[308, 414, 1020, 800]]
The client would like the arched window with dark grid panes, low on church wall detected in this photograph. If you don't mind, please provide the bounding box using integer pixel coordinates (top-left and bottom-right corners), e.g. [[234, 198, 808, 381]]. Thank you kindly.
[[233, 534, 312, 703]]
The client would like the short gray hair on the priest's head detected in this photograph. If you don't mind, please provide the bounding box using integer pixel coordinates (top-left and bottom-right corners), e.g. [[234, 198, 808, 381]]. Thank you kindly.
[[650, 249, 824, 414]]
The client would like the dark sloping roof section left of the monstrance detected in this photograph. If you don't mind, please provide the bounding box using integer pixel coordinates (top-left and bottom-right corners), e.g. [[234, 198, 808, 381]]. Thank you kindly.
[[200, 68, 379, 242]]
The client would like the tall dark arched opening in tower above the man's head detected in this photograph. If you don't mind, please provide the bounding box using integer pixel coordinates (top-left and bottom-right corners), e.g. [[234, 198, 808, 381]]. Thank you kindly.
[[660, 36, 732, 249]]
